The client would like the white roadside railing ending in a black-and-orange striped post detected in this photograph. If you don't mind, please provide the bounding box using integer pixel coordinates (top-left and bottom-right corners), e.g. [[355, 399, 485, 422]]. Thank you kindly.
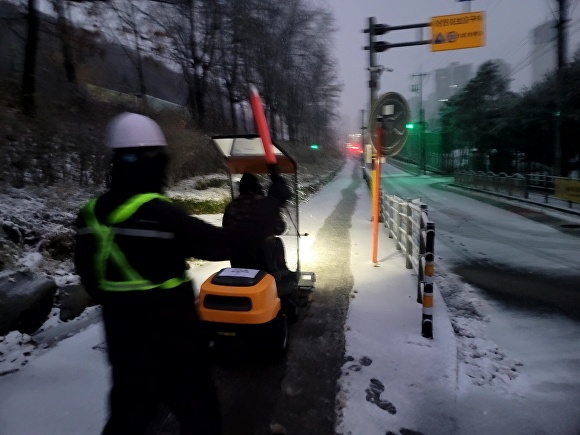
[[379, 189, 435, 338]]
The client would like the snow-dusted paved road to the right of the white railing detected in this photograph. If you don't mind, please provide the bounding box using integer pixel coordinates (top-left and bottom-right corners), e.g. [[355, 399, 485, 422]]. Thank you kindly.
[[382, 166, 580, 435]]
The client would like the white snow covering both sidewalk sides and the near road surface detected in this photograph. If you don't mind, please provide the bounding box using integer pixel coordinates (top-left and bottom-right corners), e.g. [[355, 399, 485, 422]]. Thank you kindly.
[[0, 162, 580, 435]]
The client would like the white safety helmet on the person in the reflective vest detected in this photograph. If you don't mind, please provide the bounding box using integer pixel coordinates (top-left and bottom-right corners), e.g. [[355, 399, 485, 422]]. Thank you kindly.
[[107, 112, 167, 150]]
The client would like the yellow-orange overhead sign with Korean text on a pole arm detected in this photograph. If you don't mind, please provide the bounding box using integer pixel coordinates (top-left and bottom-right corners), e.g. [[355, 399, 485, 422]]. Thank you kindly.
[[431, 12, 485, 51]]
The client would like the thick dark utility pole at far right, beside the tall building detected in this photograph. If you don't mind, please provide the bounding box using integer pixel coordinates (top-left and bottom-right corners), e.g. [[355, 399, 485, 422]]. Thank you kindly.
[[554, 0, 568, 177]]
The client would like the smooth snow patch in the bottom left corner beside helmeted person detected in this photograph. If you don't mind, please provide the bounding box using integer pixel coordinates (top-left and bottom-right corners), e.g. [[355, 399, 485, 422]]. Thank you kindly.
[[0, 323, 110, 435]]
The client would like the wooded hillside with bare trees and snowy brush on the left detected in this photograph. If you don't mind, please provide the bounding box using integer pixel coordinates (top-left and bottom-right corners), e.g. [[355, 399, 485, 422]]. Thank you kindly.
[[0, 0, 343, 272]]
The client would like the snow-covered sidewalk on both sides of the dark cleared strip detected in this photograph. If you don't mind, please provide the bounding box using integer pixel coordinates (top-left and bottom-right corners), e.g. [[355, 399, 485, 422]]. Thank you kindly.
[[0, 162, 456, 435]]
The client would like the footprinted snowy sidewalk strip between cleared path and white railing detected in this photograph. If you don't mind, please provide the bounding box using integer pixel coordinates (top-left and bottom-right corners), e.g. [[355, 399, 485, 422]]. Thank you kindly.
[[337, 165, 457, 435]]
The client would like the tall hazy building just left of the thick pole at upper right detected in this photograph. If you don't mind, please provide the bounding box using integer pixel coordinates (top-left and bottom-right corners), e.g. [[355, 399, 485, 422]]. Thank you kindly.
[[532, 21, 557, 84]]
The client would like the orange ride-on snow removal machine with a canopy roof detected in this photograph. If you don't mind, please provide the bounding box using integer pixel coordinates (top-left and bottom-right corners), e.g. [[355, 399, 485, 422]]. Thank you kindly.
[[197, 135, 316, 356]]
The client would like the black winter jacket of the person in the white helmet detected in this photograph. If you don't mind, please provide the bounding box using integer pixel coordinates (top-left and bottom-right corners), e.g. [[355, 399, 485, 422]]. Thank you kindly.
[[74, 191, 256, 300]]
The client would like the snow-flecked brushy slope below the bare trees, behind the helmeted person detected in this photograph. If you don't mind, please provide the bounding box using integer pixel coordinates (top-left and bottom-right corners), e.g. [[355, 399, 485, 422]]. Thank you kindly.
[[0, 63, 343, 276]]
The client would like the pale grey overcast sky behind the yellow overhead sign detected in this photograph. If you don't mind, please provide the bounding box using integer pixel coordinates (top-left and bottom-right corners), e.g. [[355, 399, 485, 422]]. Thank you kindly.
[[326, 0, 580, 132]]
